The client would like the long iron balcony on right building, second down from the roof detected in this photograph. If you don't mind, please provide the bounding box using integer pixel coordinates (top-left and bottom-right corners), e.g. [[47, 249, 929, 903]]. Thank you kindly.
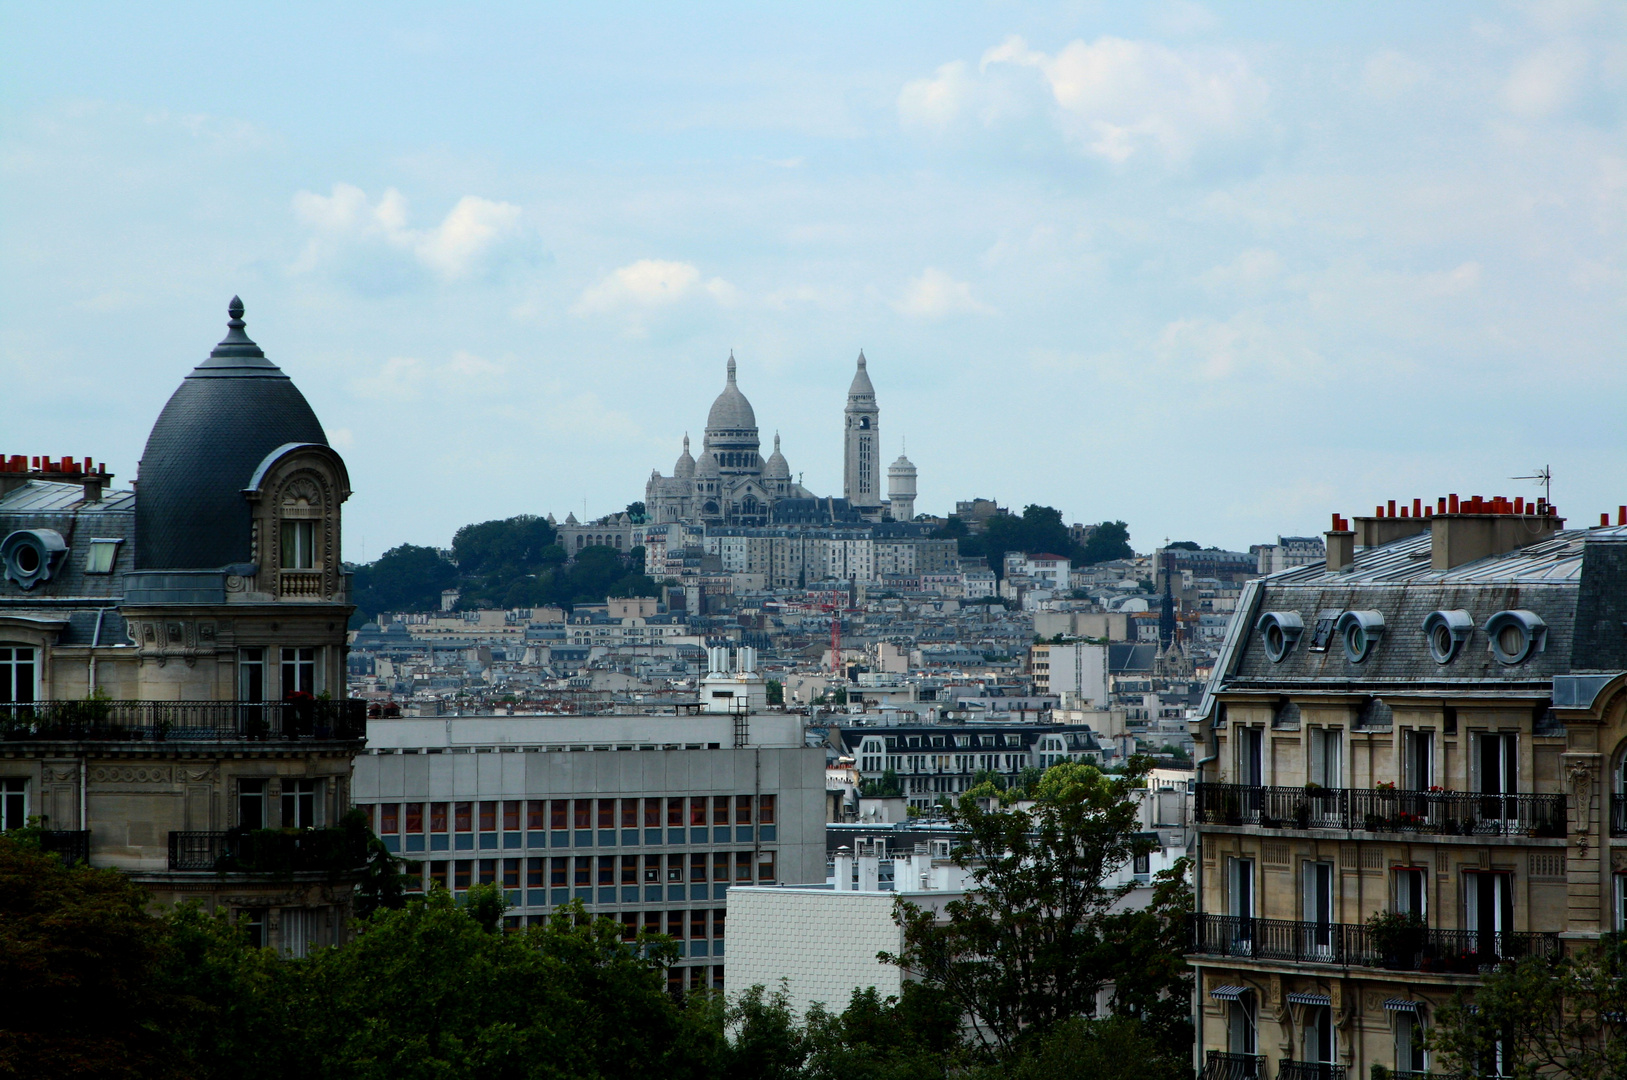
[[1193, 914, 1559, 974]]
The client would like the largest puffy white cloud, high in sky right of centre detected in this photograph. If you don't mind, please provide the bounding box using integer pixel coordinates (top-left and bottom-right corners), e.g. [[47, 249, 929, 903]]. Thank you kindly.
[[898, 36, 1269, 163]]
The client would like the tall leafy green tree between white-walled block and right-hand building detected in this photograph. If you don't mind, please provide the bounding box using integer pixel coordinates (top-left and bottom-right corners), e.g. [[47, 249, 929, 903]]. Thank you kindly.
[[885, 758, 1171, 1060]]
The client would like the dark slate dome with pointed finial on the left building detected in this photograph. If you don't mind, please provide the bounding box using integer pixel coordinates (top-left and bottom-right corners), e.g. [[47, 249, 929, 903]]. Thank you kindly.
[[135, 296, 327, 569]]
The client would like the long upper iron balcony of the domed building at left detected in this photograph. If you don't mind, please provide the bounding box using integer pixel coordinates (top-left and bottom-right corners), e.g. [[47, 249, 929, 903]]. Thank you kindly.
[[0, 698, 368, 743]]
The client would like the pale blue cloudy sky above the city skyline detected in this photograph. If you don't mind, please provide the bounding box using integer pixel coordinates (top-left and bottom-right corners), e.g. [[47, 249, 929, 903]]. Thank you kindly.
[[0, 0, 1627, 560]]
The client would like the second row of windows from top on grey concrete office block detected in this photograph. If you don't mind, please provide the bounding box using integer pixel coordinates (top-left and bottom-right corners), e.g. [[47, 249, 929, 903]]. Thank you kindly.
[[408, 851, 776, 908]]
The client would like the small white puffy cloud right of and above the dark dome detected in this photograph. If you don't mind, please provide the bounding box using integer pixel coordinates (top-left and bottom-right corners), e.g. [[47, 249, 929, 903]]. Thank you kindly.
[[294, 184, 521, 281]]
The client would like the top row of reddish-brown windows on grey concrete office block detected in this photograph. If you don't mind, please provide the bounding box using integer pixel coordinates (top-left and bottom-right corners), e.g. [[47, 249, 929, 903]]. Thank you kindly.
[[361, 795, 778, 852]]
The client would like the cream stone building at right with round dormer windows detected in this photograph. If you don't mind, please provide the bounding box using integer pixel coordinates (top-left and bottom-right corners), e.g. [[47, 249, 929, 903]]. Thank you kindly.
[[1191, 496, 1627, 1080]]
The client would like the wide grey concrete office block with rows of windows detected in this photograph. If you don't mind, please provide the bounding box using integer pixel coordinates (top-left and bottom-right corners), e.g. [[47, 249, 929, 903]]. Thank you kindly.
[[355, 712, 825, 989]]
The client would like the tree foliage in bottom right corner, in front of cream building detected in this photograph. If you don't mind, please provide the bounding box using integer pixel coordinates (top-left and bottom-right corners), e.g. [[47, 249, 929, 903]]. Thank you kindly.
[[1427, 934, 1627, 1080]]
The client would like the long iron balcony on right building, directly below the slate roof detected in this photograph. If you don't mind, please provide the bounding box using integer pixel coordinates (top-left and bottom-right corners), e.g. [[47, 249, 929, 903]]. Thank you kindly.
[[1193, 784, 1567, 839]]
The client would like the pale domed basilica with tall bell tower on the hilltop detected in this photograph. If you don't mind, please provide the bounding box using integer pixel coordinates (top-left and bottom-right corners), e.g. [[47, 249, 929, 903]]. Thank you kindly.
[[644, 351, 914, 527]]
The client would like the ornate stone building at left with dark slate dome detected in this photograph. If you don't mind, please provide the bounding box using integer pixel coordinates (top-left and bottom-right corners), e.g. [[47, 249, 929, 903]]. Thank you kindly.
[[0, 298, 366, 953]]
